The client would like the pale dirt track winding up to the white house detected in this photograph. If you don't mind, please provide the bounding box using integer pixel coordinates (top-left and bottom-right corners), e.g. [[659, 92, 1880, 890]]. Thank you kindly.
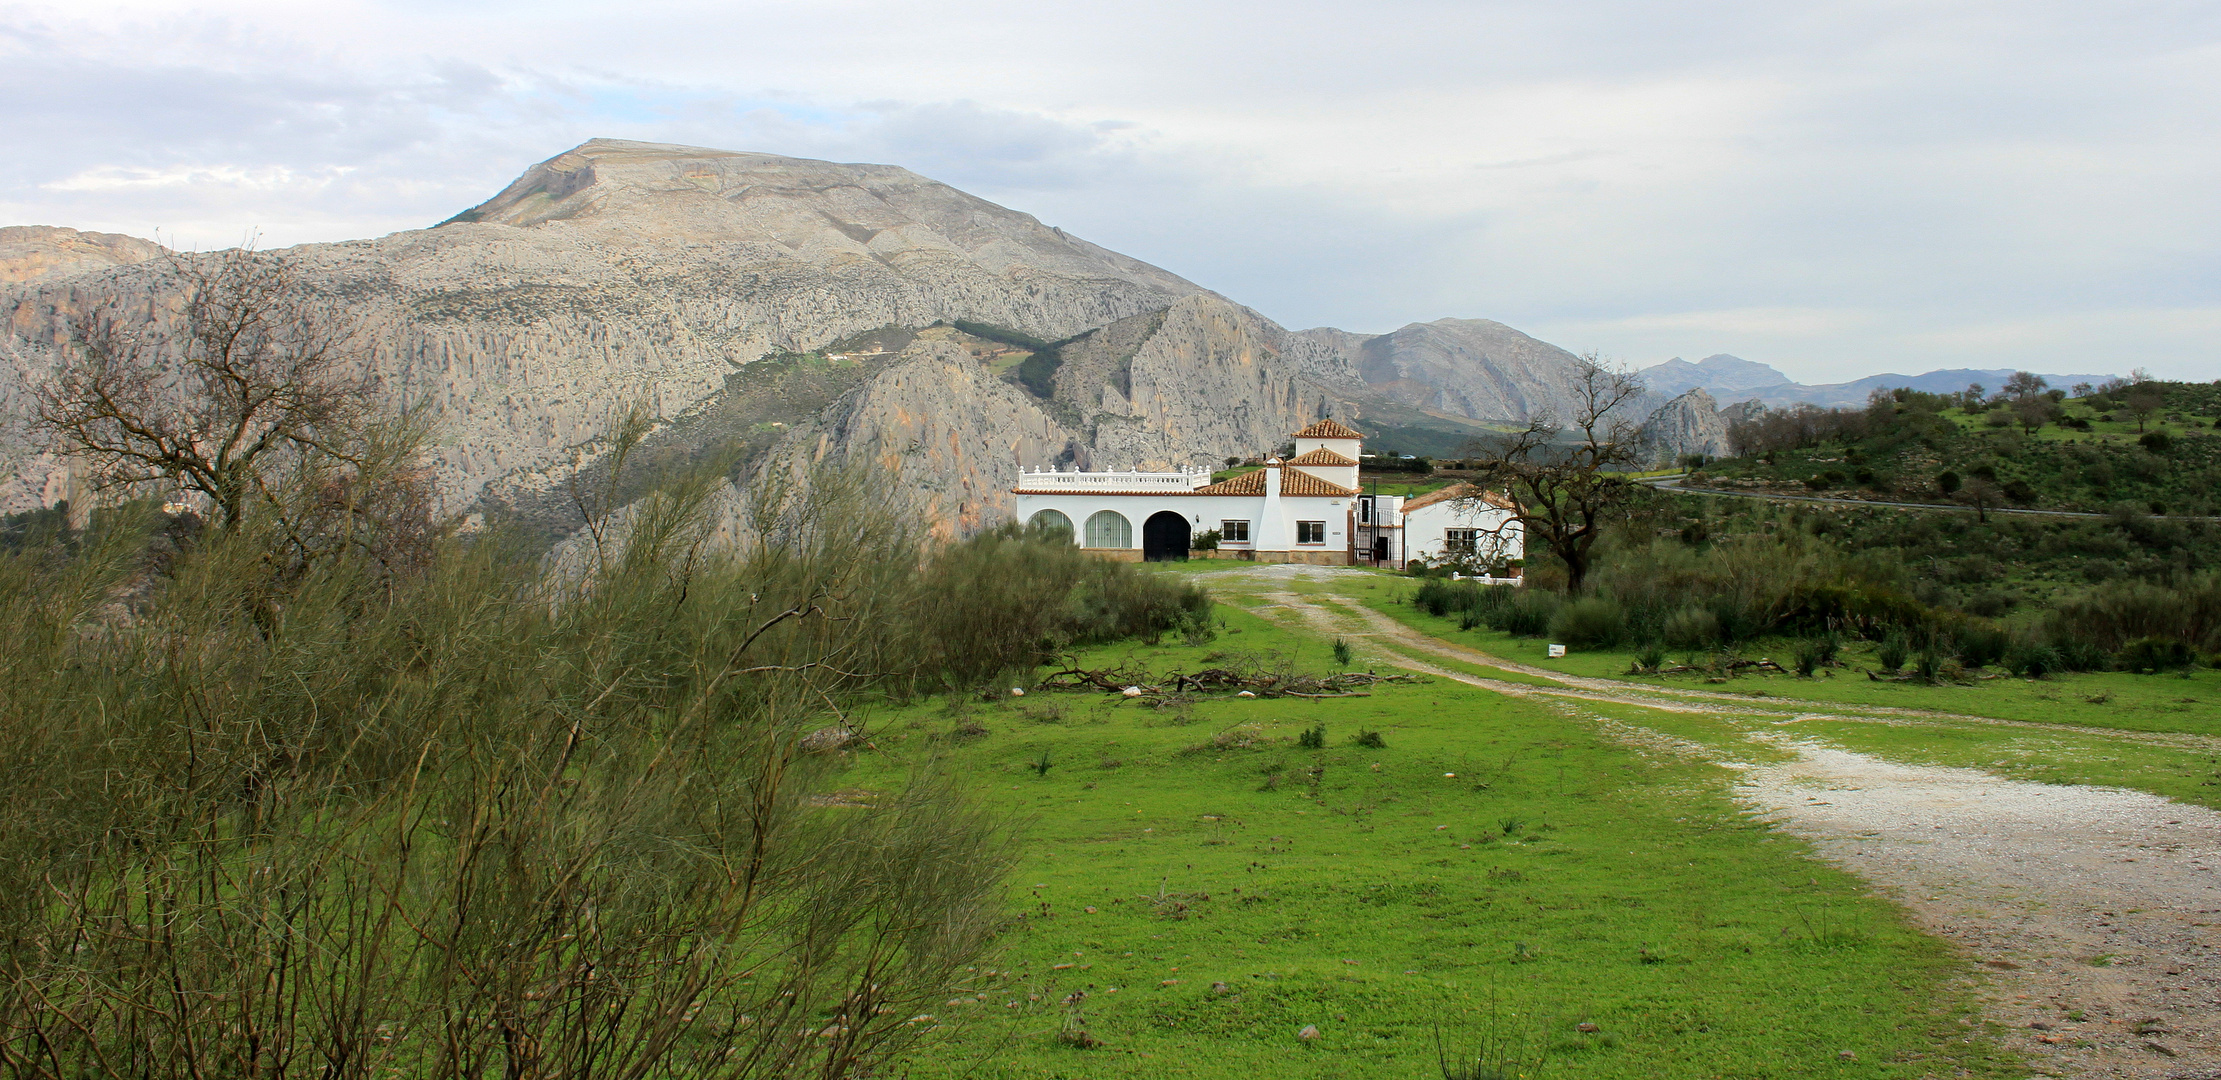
[[1208, 567, 2221, 1080]]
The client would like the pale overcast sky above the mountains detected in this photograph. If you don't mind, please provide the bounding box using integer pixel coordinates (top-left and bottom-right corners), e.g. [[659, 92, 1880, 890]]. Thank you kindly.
[[0, 0, 2221, 382]]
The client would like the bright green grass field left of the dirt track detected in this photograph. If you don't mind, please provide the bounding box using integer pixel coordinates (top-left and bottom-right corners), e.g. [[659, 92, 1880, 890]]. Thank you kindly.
[[844, 604, 2019, 1078]]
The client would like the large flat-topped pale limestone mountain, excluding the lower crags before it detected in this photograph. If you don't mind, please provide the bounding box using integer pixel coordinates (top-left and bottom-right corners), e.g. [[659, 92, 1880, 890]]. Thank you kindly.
[[0, 140, 1202, 511]]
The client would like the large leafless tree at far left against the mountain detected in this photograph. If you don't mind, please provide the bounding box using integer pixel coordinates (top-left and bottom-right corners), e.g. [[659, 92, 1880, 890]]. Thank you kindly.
[[36, 247, 378, 529]]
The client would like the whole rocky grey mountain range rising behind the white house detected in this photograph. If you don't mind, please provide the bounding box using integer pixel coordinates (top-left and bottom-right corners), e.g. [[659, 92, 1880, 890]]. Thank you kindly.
[[0, 140, 1892, 531]]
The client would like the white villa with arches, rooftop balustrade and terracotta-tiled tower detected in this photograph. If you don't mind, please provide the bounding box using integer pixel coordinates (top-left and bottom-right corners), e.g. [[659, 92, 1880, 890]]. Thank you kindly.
[[1013, 420, 1517, 567]]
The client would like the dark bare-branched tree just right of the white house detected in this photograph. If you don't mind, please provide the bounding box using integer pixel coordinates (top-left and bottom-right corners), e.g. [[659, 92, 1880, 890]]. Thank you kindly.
[[1466, 353, 1644, 593]]
